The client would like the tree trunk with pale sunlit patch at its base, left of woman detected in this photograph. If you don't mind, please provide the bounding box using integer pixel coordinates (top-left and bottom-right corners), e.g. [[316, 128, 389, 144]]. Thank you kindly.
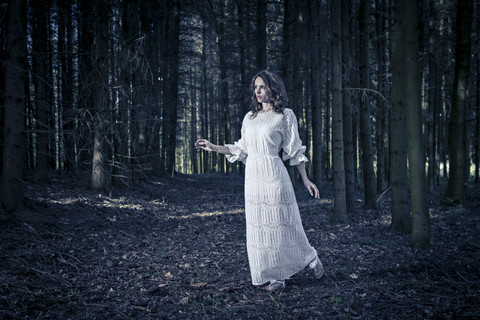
[[89, 1, 110, 192]]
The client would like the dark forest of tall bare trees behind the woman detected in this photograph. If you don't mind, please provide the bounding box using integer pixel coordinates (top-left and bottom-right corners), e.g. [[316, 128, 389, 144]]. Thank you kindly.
[[0, 0, 480, 247]]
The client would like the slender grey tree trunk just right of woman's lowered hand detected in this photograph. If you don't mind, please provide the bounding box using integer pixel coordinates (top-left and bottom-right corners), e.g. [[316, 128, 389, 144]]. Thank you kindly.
[[331, 1, 348, 222]]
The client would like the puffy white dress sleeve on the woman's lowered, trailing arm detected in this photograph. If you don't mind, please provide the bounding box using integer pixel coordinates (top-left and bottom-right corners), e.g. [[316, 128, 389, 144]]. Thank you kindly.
[[282, 109, 308, 166]]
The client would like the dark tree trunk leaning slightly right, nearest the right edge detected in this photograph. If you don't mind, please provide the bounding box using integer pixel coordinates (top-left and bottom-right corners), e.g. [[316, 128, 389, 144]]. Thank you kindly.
[[445, 0, 473, 204]]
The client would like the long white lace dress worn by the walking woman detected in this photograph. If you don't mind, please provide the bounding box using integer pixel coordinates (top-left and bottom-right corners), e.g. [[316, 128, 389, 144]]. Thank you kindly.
[[226, 108, 317, 285]]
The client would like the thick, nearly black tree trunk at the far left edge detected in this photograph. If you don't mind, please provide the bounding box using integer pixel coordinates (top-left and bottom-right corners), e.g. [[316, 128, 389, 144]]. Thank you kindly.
[[1, 0, 27, 211]]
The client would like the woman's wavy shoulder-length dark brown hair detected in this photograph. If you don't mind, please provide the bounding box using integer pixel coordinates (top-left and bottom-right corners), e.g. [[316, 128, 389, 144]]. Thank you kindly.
[[250, 70, 288, 118]]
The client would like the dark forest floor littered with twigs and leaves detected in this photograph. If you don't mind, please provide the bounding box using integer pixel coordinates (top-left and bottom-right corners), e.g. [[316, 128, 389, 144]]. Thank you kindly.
[[0, 174, 480, 319]]
